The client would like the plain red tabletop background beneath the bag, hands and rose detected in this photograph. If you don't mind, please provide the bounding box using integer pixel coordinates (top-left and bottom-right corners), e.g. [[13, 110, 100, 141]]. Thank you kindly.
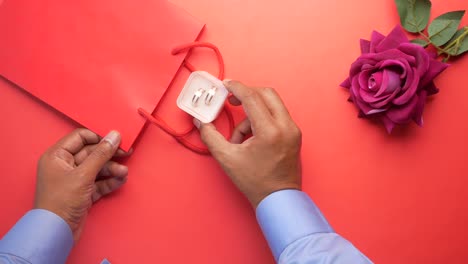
[[0, 0, 468, 264]]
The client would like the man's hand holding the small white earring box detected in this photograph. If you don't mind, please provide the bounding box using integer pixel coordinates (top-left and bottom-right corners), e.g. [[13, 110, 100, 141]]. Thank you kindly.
[[194, 81, 301, 208]]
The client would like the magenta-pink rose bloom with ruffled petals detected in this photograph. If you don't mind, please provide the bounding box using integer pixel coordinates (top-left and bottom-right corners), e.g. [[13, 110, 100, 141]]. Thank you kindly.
[[341, 26, 448, 133]]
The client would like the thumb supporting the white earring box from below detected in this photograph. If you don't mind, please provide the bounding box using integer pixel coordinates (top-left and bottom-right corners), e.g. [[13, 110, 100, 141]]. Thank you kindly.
[[193, 118, 230, 158]]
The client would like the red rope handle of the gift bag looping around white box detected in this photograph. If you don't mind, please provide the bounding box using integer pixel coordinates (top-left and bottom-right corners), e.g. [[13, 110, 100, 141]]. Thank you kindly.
[[138, 42, 234, 155]]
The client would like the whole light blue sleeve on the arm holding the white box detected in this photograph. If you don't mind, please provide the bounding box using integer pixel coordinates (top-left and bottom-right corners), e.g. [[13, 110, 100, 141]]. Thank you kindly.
[[256, 190, 372, 264]]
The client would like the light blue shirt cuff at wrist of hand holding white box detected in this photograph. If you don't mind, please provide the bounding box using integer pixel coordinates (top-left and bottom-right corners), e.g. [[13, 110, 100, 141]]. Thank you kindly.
[[256, 190, 334, 261]]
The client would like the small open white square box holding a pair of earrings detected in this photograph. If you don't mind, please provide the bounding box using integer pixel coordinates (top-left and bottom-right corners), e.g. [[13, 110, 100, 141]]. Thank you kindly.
[[177, 71, 229, 123]]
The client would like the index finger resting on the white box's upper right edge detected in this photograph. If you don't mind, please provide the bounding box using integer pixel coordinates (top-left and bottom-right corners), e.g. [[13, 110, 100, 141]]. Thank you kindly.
[[224, 80, 273, 129]]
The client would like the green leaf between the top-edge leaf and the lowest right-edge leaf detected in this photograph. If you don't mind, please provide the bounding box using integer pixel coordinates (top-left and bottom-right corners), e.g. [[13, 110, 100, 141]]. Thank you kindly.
[[428, 10, 465, 46]]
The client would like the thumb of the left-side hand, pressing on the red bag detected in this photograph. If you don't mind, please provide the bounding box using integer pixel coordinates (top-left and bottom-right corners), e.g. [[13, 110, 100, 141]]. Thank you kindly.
[[79, 131, 120, 181]]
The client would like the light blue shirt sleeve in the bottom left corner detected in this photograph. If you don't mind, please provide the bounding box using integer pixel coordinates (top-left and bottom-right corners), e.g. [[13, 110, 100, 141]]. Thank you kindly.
[[0, 209, 73, 264]]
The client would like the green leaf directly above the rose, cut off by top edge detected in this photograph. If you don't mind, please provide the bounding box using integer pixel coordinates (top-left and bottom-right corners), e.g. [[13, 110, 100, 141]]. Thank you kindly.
[[395, 0, 431, 33]]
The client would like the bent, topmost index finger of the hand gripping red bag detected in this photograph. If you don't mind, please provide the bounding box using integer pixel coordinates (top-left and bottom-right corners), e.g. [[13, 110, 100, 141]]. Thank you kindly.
[[54, 128, 99, 155]]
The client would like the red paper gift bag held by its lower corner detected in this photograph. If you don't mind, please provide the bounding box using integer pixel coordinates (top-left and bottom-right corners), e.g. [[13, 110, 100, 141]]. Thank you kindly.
[[0, 0, 204, 150]]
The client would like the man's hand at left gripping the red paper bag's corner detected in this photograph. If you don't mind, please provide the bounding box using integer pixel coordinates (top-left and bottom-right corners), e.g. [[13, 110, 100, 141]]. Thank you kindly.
[[34, 129, 128, 241]]
